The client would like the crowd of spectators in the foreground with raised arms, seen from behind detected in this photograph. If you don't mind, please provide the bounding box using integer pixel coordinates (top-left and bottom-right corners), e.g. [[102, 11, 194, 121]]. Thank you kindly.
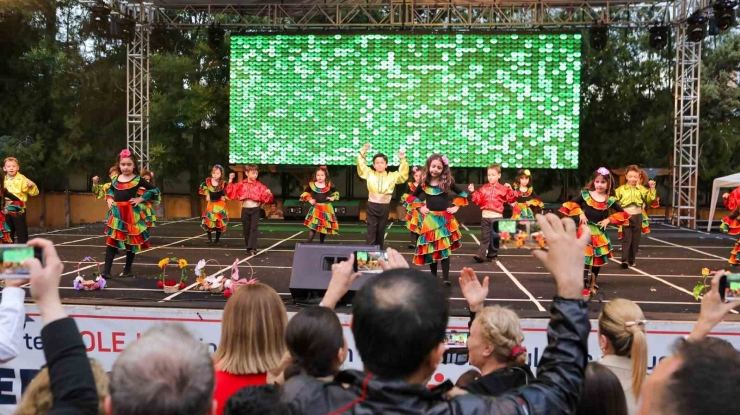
[[0, 215, 740, 415]]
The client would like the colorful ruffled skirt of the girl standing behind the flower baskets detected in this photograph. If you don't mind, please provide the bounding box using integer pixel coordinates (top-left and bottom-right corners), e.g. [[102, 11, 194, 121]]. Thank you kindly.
[[105, 202, 149, 253]]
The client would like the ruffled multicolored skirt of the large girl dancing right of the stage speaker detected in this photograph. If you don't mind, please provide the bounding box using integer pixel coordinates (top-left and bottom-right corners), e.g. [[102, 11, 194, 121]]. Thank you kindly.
[[414, 211, 462, 265]]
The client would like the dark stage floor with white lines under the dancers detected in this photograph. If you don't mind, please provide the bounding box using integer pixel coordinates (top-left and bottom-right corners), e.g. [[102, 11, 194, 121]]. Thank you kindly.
[[10, 218, 740, 321]]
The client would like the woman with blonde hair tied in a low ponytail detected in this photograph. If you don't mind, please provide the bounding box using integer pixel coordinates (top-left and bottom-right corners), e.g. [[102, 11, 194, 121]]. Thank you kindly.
[[599, 298, 647, 415]]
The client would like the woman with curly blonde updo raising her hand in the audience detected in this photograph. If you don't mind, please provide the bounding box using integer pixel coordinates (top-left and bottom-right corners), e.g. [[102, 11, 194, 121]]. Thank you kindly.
[[460, 268, 534, 396]]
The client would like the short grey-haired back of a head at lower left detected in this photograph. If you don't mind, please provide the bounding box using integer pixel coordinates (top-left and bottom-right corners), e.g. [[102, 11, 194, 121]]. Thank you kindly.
[[110, 324, 214, 415]]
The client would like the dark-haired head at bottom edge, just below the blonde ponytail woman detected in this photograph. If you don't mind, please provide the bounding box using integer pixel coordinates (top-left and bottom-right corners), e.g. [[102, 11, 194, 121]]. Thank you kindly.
[[576, 362, 627, 415]]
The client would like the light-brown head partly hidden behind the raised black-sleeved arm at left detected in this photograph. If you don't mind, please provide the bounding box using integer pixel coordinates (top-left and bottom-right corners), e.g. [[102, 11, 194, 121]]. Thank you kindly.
[[14, 359, 108, 415]]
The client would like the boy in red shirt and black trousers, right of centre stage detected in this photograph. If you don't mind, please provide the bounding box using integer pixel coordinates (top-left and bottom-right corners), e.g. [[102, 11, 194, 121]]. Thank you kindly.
[[468, 164, 517, 262]]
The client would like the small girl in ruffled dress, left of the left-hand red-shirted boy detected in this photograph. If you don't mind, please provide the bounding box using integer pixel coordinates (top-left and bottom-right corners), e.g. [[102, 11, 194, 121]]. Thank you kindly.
[[198, 164, 229, 245]]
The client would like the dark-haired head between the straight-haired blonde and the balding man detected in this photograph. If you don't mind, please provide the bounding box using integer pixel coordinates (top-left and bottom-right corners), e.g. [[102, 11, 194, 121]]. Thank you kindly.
[[285, 307, 348, 381]]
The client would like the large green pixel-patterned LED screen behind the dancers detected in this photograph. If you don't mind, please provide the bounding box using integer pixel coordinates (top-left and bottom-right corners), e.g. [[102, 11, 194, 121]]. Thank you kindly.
[[229, 33, 581, 169]]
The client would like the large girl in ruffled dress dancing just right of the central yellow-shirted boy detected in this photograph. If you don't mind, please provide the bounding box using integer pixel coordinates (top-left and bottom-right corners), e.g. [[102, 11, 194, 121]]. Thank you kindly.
[[407, 154, 468, 285]]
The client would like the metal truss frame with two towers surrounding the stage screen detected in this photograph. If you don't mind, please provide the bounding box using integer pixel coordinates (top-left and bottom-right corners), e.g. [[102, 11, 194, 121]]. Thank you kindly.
[[81, 0, 709, 229]]
